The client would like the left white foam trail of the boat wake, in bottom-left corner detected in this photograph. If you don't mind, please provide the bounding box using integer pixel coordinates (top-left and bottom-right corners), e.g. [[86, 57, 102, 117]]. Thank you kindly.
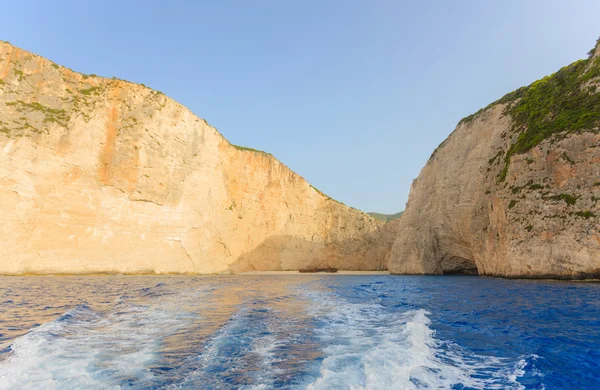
[[0, 284, 211, 389]]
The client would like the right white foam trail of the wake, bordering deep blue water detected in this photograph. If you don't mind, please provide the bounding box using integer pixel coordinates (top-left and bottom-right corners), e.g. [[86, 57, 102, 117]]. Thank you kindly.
[[305, 291, 540, 390]]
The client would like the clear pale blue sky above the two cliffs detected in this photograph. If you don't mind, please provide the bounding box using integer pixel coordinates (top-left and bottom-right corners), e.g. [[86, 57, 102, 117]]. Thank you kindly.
[[0, 0, 600, 213]]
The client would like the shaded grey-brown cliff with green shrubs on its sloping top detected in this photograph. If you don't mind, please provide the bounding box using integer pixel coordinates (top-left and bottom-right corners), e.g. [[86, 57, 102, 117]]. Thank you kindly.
[[389, 39, 600, 279]]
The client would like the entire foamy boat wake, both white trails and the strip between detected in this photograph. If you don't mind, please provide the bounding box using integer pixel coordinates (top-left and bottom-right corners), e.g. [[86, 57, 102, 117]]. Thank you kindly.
[[0, 285, 543, 390]]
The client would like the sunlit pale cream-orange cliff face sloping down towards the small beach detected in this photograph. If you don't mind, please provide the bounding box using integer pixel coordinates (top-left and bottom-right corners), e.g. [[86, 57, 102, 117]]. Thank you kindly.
[[0, 42, 391, 274]]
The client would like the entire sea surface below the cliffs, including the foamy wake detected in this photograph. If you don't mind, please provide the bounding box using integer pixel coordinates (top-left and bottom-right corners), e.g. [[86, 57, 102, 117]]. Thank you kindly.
[[0, 275, 600, 389]]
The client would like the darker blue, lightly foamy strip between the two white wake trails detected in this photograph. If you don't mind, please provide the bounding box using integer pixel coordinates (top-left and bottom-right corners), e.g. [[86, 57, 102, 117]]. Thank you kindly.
[[170, 297, 318, 389]]
